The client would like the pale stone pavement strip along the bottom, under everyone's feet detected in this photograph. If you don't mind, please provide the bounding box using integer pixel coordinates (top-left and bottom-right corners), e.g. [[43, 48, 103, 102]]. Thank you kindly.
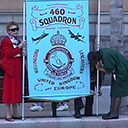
[[0, 115, 128, 128]]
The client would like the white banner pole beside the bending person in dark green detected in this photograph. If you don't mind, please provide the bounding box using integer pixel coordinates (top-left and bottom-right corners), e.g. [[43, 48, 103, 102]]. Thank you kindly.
[[96, 0, 100, 116]]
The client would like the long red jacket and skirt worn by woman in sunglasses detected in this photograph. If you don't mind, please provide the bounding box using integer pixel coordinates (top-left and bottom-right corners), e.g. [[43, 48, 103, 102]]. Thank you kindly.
[[1, 37, 22, 103]]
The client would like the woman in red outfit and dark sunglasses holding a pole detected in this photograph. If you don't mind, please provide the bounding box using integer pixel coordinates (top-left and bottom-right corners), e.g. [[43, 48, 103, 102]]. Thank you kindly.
[[1, 22, 26, 121]]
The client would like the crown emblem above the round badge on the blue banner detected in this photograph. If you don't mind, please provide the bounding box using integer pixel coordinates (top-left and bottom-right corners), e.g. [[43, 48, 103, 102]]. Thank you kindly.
[[50, 31, 67, 46]]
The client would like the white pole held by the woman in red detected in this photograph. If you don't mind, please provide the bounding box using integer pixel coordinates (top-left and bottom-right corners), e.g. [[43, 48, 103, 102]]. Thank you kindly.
[[22, 0, 26, 120]]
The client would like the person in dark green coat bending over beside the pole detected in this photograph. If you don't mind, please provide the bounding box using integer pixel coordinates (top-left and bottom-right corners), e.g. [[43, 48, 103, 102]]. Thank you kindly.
[[88, 48, 128, 119]]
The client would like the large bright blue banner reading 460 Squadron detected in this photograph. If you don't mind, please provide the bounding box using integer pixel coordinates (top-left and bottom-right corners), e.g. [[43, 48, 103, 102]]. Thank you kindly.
[[26, 0, 90, 101]]
